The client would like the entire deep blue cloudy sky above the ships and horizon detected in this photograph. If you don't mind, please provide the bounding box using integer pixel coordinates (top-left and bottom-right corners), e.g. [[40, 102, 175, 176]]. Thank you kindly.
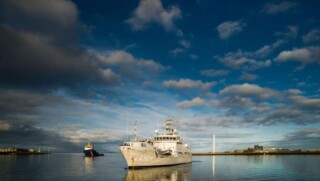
[[0, 0, 320, 152]]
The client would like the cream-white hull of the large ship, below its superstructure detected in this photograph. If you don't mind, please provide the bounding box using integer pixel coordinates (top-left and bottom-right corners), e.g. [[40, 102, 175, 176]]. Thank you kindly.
[[120, 147, 192, 168]]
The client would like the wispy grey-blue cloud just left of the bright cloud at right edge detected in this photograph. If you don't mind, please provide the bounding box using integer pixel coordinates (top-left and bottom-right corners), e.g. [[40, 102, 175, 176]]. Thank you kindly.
[[214, 50, 271, 70]]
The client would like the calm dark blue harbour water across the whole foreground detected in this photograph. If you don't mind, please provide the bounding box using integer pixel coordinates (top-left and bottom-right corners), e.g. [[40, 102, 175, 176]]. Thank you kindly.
[[0, 154, 320, 181]]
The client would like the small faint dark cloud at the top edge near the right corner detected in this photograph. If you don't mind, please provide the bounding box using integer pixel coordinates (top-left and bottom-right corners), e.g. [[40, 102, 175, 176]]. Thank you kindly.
[[261, 1, 297, 14]]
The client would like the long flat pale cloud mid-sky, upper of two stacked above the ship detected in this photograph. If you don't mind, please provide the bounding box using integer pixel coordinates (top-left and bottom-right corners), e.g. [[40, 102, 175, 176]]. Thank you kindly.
[[163, 79, 216, 90]]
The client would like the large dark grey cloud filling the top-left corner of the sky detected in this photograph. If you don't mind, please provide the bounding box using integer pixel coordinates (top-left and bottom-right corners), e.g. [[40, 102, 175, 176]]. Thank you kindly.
[[1, 0, 80, 45]]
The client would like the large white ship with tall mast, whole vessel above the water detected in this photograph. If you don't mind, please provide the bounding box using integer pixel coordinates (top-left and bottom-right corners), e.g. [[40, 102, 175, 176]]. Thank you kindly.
[[119, 118, 192, 167]]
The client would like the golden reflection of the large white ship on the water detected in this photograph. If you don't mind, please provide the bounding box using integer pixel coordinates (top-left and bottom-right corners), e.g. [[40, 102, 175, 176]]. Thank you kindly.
[[124, 164, 192, 181]]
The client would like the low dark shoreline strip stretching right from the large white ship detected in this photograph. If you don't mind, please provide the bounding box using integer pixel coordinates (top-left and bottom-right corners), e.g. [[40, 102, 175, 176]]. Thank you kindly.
[[192, 151, 320, 156]]
